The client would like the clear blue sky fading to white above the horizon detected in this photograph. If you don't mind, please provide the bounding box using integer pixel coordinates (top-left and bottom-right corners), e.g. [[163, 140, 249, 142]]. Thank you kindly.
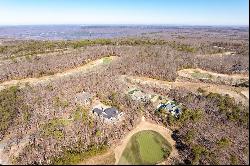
[[0, 0, 249, 25]]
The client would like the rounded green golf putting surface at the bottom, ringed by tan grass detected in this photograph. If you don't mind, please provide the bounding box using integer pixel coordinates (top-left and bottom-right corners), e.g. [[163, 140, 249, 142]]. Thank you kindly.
[[119, 130, 172, 164]]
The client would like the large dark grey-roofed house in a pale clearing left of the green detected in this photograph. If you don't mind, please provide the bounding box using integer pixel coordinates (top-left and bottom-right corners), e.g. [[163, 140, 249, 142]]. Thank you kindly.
[[92, 107, 123, 122]]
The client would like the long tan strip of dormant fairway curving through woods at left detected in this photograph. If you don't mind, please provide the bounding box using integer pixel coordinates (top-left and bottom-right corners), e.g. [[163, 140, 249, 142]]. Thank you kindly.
[[0, 56, 117, 90]]
